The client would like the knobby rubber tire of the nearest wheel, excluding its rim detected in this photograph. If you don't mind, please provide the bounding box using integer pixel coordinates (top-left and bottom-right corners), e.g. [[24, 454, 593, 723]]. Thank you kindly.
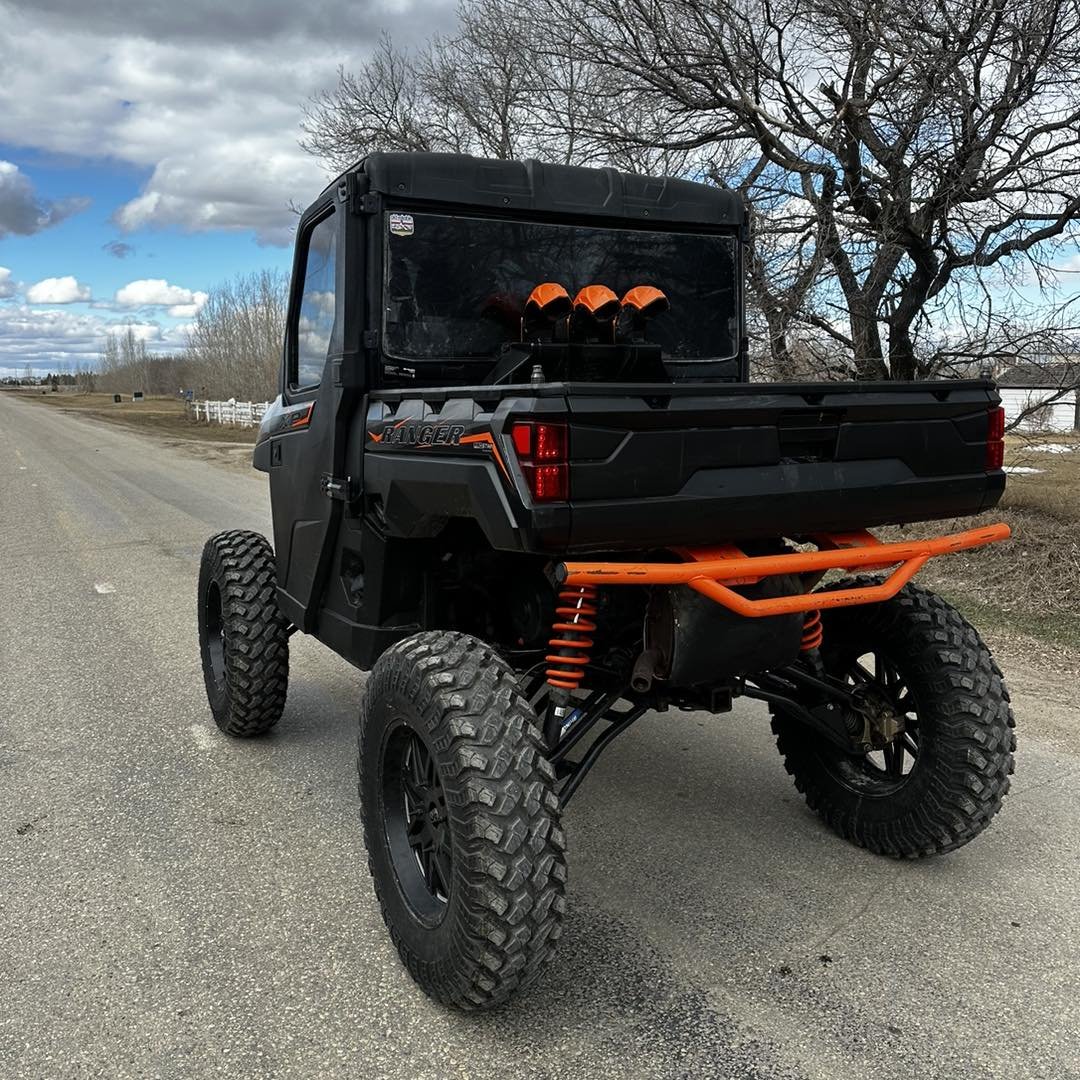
[[359, 631, 566, 1010]]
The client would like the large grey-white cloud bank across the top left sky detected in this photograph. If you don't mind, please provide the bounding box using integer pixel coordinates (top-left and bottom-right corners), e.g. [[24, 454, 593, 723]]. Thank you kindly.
[[0, 6, 454, 244]]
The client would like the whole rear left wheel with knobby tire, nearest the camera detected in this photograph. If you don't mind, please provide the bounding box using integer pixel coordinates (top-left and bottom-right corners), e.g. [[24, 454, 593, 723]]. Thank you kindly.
[[359, 632, 566, 1009]]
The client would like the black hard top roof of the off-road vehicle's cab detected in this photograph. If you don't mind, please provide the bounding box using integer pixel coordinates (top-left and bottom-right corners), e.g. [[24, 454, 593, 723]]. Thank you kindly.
[[326, 153, 746, 226]]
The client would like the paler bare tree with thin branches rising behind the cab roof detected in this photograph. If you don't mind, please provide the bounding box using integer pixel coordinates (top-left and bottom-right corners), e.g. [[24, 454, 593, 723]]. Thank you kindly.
[[301, 0, 688, 174]]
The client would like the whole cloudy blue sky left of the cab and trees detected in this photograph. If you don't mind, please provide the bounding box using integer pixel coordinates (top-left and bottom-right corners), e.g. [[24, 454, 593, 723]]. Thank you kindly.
[[0, 0, 454, 375]]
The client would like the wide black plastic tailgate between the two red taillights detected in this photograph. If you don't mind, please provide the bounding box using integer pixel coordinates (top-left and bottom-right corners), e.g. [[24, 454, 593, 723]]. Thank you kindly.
[[566, 381, 1004, 549]]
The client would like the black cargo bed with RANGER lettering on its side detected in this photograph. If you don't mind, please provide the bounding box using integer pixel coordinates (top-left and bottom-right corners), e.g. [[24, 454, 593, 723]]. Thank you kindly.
[[352, 382, 1004, 554]]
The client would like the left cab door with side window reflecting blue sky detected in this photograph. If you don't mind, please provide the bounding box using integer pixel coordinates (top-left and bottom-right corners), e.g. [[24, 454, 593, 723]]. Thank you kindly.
[[270, 195, 348, 633]]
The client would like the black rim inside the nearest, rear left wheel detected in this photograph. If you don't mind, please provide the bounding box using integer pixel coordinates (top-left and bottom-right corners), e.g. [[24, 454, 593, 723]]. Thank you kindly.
[[382, 721, 454, 924]]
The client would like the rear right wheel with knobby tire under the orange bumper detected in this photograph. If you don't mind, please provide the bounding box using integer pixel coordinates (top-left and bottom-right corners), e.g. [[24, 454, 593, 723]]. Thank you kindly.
[[772, 579, 1016, 859]]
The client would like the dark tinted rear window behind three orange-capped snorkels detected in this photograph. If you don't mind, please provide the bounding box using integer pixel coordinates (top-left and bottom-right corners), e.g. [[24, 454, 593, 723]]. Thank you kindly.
[[383, 211, 739, 366]]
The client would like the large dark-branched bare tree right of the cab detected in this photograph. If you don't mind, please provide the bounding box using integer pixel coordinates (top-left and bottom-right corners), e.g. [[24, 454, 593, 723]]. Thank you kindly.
[[533, 0, 1080, 378]]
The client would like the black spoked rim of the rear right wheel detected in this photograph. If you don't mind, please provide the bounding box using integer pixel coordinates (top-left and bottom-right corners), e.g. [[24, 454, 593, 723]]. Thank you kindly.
[[823, 648, 922, 798]]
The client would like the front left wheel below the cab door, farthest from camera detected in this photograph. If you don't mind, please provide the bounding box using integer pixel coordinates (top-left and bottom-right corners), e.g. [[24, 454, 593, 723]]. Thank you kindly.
[[199, 530, 288, 739]]
